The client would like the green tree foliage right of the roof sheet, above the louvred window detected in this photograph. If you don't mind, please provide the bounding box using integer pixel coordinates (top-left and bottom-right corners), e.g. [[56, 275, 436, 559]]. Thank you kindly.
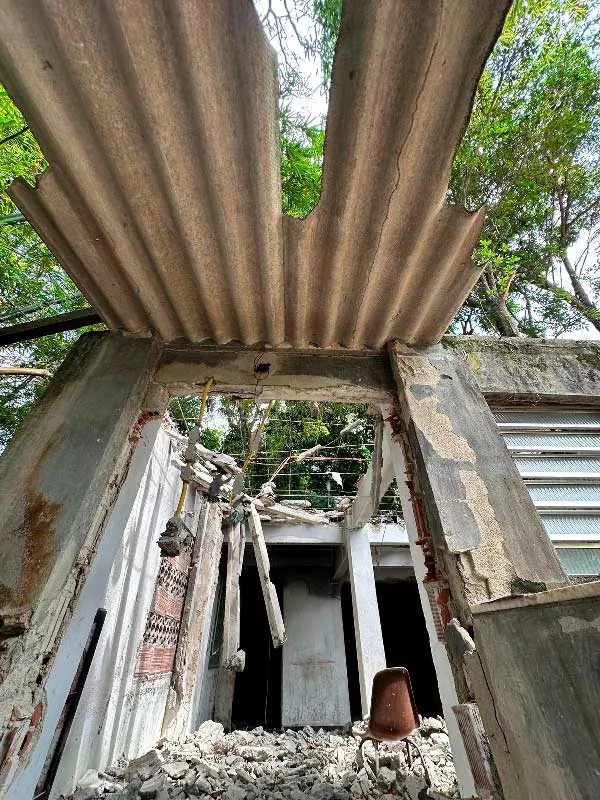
[[449, 0, 600, 336]]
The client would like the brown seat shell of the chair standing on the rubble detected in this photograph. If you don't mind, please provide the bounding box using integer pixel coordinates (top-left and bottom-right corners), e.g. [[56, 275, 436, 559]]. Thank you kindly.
[[367, 667, 420, 742]]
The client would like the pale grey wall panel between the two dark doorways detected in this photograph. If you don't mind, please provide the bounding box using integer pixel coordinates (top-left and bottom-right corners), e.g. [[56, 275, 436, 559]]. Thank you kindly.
[[281, 571, 350, 728]]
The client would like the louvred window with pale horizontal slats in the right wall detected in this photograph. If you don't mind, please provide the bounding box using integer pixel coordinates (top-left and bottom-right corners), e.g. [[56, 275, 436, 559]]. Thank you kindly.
[[494, 410, 600, 575]]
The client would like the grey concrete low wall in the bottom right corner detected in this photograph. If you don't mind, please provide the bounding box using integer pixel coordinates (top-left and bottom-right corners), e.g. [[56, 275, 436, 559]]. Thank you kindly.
[[467, 581, 600, 800]]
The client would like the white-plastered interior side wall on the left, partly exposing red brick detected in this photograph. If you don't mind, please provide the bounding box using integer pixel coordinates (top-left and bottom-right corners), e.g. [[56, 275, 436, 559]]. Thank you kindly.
[[51, 422, 197, 800]]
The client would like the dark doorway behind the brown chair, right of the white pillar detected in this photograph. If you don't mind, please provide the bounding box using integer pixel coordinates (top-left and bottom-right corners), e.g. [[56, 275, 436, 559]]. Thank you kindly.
[[376, 580, 442, 717]]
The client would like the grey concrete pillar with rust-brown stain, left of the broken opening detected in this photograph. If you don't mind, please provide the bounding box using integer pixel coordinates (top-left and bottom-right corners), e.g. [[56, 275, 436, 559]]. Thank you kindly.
[[0, 333, 160, 790]]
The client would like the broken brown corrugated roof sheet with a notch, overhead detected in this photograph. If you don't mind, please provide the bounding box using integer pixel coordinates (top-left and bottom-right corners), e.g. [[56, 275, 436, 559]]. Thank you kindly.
[[0, 0, 509, 348]]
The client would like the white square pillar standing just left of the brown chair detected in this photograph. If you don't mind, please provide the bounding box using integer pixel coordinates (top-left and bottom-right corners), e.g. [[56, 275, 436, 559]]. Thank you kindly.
[[344, 526, 386, 716]]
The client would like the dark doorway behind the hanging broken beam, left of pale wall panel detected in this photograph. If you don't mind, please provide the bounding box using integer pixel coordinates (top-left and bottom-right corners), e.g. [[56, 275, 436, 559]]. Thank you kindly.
[[231, 566, 285, 728]]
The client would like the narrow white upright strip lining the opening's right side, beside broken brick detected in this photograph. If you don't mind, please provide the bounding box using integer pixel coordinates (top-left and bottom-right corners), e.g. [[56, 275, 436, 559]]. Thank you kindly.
[[383, 424, 477, 797]]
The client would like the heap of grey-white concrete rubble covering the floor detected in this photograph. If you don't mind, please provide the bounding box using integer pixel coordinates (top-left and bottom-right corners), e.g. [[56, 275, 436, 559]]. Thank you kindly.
[[64, 718, 459, 800]]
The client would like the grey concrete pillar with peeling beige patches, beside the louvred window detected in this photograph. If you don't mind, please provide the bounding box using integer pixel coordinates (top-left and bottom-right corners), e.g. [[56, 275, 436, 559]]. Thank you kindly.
[[391, 344, 568, 623]]
